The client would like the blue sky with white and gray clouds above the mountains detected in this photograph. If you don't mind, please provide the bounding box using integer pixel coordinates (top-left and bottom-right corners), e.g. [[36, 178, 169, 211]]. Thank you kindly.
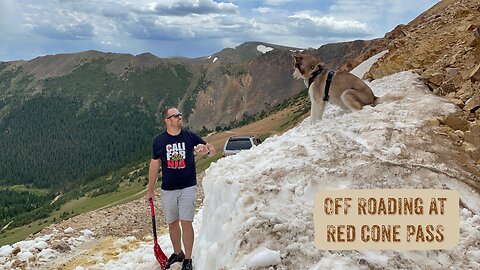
[[0, 0, 439, 61]]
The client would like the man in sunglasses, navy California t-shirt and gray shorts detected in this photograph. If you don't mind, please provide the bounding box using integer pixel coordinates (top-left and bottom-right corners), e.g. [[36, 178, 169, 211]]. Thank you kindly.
[[147, 107, 216, 270]]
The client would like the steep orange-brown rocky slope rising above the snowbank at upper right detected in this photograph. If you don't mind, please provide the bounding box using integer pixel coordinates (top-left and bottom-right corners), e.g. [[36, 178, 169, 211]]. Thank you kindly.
[[357, 0, 480, 163]]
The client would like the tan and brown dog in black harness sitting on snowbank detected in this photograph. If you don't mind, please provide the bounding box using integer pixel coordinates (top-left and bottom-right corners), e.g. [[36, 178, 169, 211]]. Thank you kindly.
[[292, 53, 379, 124]]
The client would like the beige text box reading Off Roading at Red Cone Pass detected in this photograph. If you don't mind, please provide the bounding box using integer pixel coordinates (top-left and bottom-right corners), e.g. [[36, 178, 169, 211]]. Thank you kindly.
[[313, 189, 460, 250]]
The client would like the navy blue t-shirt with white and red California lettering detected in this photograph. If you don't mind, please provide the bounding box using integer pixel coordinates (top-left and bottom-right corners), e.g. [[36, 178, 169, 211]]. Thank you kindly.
[[152, 129, 206, 190]]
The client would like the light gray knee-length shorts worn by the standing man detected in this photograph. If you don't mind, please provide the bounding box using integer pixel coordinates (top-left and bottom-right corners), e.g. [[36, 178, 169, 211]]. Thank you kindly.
[[162, 186, 197, 224]]
